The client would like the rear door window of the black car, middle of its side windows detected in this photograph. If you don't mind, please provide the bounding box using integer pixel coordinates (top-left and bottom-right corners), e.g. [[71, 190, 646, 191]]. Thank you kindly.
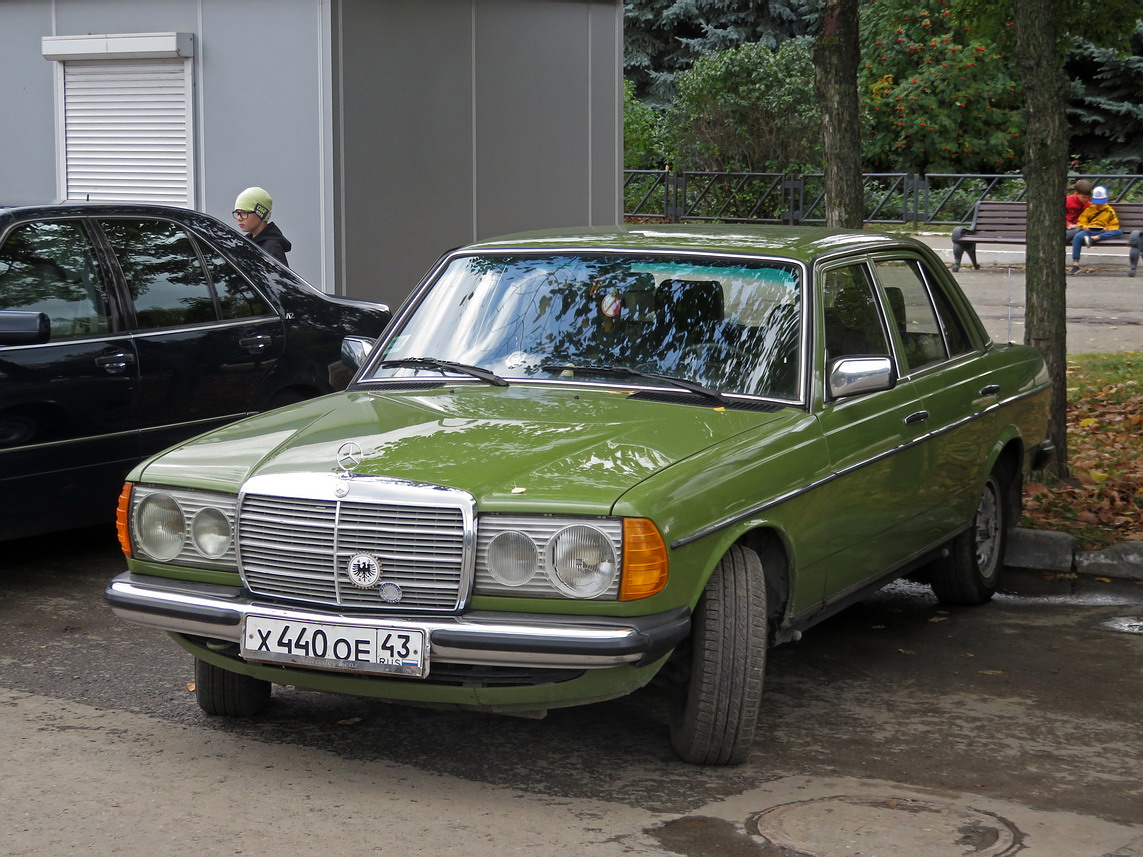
[[101, 219, 217, 328]]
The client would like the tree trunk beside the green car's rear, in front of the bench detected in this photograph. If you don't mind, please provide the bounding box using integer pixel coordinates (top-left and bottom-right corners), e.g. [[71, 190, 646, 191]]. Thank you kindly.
[[1013, 0, 1070, 476]]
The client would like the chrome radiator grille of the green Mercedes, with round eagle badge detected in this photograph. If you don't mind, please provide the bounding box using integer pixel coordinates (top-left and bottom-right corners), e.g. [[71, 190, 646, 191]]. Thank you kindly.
[[238, 483, 471, 610]]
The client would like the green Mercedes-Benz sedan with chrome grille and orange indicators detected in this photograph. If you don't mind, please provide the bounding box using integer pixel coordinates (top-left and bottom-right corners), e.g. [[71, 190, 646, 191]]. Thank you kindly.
[[106, 225, 1050, 764]]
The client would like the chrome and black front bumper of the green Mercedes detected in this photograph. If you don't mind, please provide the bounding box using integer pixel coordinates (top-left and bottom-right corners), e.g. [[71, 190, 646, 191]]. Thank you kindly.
[[104, 571, 690, 670]]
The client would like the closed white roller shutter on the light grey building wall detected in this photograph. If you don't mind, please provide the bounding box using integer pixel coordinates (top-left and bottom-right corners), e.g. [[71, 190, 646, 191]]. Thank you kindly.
[[62, 58, 194, 207]]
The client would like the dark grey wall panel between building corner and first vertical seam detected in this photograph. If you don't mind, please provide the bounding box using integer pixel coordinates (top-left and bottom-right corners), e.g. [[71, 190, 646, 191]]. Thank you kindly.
[[336, 0, 474, 305]]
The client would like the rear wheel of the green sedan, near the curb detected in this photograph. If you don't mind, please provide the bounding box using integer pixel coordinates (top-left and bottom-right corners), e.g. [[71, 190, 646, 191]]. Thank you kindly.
[[929, 472, 1008, 604]]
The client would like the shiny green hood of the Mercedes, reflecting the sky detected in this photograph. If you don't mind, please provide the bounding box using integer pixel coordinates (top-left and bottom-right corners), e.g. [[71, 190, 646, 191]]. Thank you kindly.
[[133, 384, 791, 514]]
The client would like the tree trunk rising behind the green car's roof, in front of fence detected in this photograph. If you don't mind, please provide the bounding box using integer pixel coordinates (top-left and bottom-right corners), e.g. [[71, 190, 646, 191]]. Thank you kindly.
[[814, 0, 865, 229]]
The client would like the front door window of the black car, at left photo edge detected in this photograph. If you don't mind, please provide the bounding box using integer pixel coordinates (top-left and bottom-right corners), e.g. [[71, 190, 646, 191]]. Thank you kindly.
[[0, 221, 111, 339]]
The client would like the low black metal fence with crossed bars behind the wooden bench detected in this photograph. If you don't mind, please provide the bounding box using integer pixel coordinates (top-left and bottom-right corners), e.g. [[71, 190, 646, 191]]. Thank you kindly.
[[623, 169, 1143, 226]]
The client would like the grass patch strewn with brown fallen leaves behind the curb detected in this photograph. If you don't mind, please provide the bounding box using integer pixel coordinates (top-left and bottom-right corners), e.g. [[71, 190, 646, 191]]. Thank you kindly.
[[1022, 352, 1143, 550]]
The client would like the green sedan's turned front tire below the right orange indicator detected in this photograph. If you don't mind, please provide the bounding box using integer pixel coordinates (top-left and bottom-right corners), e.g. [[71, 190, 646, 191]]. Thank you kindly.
[[671, 546, 768, 764]]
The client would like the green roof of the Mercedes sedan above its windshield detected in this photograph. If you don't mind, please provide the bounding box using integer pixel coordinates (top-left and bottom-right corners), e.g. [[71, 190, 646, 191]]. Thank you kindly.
[[461, 224, 922, 262]]
